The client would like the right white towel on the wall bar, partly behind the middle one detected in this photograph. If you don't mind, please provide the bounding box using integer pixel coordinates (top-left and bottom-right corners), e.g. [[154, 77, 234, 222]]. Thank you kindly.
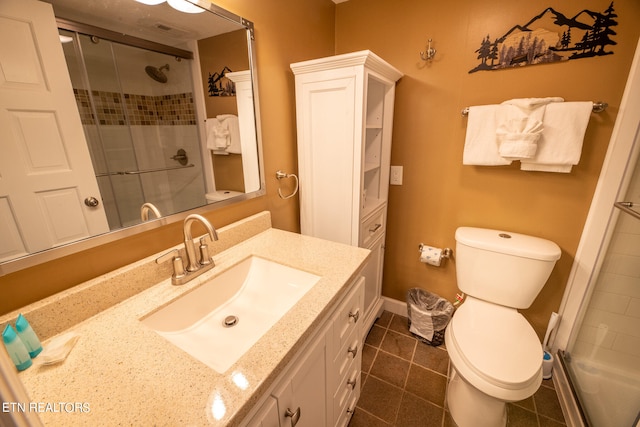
[[520, 102, 593, 173]]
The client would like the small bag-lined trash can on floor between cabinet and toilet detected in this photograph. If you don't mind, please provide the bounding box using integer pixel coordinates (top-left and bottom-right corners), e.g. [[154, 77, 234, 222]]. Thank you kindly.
[[407, 288, 453, 346]]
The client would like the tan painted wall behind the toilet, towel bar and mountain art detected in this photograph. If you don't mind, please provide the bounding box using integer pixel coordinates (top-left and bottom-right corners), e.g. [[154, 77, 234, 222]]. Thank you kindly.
[[336, 0, 640, 340]]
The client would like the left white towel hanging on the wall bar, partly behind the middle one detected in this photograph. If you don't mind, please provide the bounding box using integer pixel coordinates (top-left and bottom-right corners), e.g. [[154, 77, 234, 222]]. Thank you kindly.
[[462, 105, 511, 166]]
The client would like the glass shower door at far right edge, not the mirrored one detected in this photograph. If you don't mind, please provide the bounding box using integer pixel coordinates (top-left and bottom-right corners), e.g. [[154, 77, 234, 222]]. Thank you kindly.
[[565, 152, 640, 427]]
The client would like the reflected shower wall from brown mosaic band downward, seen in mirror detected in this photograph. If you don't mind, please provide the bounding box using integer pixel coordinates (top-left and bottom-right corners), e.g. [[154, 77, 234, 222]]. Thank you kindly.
[[74, 89, 205, 228]]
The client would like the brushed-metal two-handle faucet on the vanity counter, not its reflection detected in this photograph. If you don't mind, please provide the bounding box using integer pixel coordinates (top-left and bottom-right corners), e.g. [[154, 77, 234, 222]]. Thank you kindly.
[[156, 214, 218, 285]]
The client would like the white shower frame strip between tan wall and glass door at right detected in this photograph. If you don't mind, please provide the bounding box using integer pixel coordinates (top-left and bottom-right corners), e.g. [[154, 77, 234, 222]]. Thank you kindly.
[[552, 40, 640, 426]]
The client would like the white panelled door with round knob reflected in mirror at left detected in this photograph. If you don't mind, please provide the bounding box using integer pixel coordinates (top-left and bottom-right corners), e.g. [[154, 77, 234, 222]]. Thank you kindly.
[[0, 0, 109, 261]]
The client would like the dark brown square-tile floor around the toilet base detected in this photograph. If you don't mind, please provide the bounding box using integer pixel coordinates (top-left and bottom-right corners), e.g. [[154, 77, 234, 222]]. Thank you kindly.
[[349, 311, 565, 427]]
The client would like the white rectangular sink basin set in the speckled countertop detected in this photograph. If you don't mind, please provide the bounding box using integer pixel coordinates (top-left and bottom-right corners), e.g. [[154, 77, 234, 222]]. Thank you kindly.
[[141, 256, 320, 373]]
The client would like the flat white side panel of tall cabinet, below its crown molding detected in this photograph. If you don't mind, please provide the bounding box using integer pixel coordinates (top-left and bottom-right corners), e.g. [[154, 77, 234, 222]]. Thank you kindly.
[[296, 76, 360, 245]]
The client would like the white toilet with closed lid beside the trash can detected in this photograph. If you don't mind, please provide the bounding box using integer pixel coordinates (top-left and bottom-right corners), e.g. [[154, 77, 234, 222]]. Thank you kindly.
[[445, 227, 560, 427]]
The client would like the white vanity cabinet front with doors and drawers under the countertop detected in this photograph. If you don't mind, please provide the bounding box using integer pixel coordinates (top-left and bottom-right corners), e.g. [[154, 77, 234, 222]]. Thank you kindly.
[[241, 277, 365, 427]]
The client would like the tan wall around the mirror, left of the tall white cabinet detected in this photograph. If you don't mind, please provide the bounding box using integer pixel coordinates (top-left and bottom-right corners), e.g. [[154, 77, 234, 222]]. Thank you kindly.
[[0, 0, 335, 314]]
